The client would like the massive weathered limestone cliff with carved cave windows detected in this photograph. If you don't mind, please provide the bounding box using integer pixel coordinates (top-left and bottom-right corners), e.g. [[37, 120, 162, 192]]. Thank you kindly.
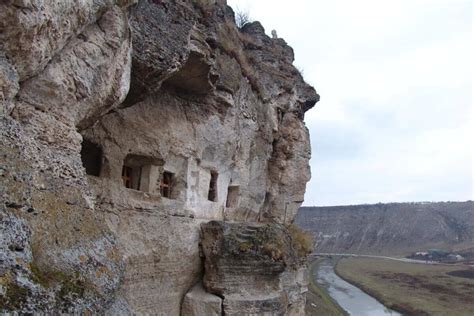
[[0, 0, 319, 315]]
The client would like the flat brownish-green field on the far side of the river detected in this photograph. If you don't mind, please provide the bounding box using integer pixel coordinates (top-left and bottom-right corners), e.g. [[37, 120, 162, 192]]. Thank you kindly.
[[336, 257, 474, 315]]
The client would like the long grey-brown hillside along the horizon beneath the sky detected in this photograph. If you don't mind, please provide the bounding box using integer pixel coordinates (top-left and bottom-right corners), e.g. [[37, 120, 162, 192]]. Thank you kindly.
[[295, 201, 474, 254]]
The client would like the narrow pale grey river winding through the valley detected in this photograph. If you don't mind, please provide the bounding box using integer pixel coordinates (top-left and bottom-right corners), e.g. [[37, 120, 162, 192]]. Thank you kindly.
[[313, 260, 401, 316]]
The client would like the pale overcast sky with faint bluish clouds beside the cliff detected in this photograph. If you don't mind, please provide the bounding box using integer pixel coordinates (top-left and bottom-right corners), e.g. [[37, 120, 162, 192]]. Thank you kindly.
[[228, 0, 474, 205]]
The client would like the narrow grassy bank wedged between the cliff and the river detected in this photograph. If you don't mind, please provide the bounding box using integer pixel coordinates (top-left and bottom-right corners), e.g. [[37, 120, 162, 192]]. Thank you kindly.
[[306, 258, 348, 316]]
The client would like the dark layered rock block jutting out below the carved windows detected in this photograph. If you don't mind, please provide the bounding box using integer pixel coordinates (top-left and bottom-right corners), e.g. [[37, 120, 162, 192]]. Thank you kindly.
[[201, 221, 307, 315]]
